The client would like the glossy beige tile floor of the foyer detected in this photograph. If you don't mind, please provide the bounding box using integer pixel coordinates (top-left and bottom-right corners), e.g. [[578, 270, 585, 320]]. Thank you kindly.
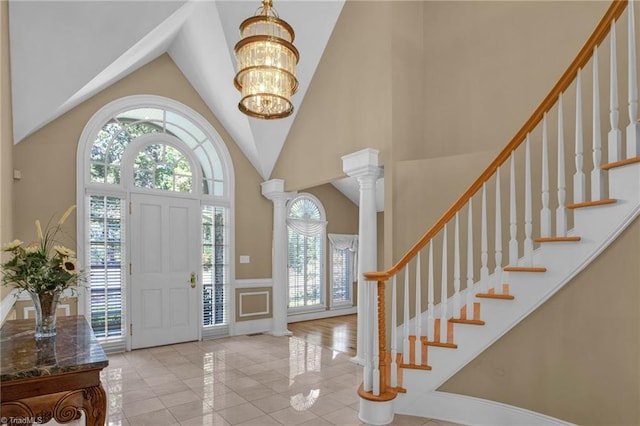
[[102, 335, 462, 426]]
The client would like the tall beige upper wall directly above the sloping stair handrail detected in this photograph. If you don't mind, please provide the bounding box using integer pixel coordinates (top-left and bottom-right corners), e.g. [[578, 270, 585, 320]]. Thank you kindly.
[[410, 1, 610, 159]]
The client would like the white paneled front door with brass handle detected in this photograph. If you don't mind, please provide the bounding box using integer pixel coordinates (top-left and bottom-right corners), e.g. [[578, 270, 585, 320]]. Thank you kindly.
[[130, 193, 202, 349]]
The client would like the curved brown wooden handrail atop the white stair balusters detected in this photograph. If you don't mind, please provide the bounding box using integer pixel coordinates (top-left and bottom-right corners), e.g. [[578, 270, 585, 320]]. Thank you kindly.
[[364, 0, 628, 282]]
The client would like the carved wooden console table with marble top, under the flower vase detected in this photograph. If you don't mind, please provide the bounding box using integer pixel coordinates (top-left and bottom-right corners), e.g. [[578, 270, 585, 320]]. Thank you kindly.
[[0, 316, 109, 426]]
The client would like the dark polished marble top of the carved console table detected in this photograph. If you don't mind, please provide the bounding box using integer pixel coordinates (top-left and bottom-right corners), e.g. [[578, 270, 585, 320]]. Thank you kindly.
[[0, 316, 109, 382]]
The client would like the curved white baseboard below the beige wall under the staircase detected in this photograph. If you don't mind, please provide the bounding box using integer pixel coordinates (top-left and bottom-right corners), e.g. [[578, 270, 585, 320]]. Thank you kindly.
[[395, 391, 573, 426]]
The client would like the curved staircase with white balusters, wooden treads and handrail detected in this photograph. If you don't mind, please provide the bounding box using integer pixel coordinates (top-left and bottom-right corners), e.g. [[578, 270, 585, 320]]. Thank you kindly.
[[358, 1, 640, 425]]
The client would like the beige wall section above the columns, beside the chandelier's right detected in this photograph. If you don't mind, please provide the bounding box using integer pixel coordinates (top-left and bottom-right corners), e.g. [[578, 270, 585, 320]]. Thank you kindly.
[[272, 1, 391, 190]]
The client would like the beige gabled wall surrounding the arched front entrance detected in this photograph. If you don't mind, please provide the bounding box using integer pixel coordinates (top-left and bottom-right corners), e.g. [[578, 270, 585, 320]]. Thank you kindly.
[[14, 55, 273, 278]]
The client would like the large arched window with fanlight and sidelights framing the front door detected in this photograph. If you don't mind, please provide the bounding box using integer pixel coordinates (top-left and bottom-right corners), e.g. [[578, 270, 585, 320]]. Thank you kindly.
[[77, 95, 233, 350]]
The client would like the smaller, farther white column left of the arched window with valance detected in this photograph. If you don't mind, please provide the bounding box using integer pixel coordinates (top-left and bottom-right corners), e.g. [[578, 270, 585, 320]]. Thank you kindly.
[[261, 179, 291, 336]]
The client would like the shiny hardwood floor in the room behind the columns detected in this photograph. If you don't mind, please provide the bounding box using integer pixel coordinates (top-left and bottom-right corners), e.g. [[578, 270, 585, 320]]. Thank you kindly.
[[289, 314, 357, 355]]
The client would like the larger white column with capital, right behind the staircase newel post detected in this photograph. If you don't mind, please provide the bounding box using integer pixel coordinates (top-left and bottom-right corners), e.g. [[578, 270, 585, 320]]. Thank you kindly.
[[342, 148, 381, 366]]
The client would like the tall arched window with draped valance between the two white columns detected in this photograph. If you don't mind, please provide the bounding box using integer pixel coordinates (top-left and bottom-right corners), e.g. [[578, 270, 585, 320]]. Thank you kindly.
[[287, 194, 326, 311]]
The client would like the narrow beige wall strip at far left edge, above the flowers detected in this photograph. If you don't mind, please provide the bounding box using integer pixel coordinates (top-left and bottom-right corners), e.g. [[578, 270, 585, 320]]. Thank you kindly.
[[0, 1, 13, 300]]
